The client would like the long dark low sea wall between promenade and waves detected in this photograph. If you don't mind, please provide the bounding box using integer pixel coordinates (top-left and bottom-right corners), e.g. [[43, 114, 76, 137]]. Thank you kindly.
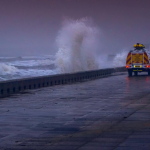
[[0, 67, 127, 97]]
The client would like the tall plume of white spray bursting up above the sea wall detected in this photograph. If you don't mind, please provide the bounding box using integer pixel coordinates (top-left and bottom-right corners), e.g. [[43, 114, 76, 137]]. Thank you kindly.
[[56, 18, 99, 73]]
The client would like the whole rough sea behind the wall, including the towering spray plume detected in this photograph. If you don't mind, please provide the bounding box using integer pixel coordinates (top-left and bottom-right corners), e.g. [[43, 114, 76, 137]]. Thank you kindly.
[[0, 18, 127, 81]]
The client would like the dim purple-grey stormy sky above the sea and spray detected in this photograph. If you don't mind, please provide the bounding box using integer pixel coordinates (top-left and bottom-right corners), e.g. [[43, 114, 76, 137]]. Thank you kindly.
[[0, 0, 150, 56]]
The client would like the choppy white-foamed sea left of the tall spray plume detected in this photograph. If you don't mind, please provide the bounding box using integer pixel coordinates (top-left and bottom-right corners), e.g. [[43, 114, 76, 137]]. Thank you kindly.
[[0, 55, 58, 81]]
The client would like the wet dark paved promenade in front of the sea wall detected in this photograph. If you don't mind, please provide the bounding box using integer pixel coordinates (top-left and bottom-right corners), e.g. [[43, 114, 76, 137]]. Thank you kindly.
[[0, 73, 150, 150]]
